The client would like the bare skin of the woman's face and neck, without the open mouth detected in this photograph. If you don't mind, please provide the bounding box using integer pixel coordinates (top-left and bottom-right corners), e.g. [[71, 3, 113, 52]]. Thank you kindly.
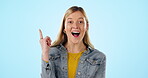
[[64, 11, 88, 53]]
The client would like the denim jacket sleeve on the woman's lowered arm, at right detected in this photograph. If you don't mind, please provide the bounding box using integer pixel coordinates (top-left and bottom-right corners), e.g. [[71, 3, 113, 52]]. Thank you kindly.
[[94, 56, 106, 78]]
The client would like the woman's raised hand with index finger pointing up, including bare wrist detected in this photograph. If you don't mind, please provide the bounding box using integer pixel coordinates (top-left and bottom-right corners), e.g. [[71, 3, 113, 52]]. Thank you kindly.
[[39, 29, 51, 62]]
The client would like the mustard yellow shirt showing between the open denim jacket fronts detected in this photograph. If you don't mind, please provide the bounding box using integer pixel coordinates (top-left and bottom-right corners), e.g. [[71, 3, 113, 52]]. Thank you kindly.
[[68, 51, 84, 78]]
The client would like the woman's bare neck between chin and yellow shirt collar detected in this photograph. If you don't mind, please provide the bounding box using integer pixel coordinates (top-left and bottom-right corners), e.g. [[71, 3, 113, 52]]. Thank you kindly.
[[65, 42, 86, 53]]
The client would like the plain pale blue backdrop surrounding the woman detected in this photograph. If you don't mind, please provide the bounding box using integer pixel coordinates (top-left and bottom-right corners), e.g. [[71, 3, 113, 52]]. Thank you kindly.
[[0, 0, 148, 78]]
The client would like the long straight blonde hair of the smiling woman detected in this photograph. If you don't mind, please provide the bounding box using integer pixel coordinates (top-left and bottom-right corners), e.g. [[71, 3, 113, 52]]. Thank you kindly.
[[51, 6, 94, 48]]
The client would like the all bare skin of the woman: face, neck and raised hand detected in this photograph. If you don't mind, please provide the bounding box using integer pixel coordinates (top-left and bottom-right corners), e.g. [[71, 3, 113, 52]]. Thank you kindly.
[[39, 11, 88, 61]]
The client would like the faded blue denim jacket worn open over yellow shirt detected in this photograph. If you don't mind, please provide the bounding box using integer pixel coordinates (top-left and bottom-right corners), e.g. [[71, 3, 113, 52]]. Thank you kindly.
[[41, 44, 106, 78]]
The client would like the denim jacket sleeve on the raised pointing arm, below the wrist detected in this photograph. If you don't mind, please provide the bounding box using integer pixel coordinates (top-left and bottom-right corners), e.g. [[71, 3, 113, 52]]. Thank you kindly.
[[41, 60, 56, 78]]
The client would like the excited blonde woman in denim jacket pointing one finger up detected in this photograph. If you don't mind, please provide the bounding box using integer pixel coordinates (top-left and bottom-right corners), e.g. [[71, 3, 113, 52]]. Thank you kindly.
[[39, 6, 106, 78]]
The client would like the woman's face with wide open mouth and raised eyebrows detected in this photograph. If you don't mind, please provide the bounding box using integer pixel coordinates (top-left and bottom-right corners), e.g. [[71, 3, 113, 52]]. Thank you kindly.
[[64, 11, 88, 43]]
